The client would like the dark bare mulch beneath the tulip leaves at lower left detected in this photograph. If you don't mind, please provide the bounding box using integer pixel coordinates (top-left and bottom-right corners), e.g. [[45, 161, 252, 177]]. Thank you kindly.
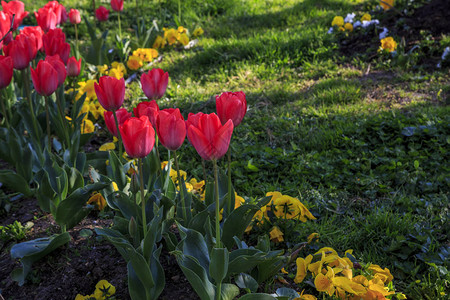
[[0, 199, 199, 300]]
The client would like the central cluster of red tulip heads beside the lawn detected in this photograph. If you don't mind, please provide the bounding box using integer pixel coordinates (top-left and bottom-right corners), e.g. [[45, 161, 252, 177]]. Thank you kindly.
[[95, 69, 247, 160]]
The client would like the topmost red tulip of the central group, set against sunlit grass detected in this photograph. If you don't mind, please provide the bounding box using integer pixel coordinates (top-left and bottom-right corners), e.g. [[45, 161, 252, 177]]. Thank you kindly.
[[141, 69, 169, 100]]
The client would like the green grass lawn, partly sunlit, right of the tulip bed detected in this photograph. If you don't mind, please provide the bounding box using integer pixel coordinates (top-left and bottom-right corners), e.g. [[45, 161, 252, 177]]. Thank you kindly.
[[15, 0, 450, 299]]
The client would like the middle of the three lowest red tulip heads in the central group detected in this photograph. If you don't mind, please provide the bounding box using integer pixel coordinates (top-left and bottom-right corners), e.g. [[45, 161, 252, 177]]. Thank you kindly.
[[156, 108, 186, 151]]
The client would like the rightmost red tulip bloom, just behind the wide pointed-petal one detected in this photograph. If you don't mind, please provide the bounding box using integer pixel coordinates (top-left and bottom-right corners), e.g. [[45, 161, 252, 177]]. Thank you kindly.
[[216, 92, 247, 127]]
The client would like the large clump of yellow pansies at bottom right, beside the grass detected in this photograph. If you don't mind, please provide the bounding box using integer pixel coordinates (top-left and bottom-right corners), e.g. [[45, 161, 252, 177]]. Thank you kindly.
[[294, 247, 406, 299]]
